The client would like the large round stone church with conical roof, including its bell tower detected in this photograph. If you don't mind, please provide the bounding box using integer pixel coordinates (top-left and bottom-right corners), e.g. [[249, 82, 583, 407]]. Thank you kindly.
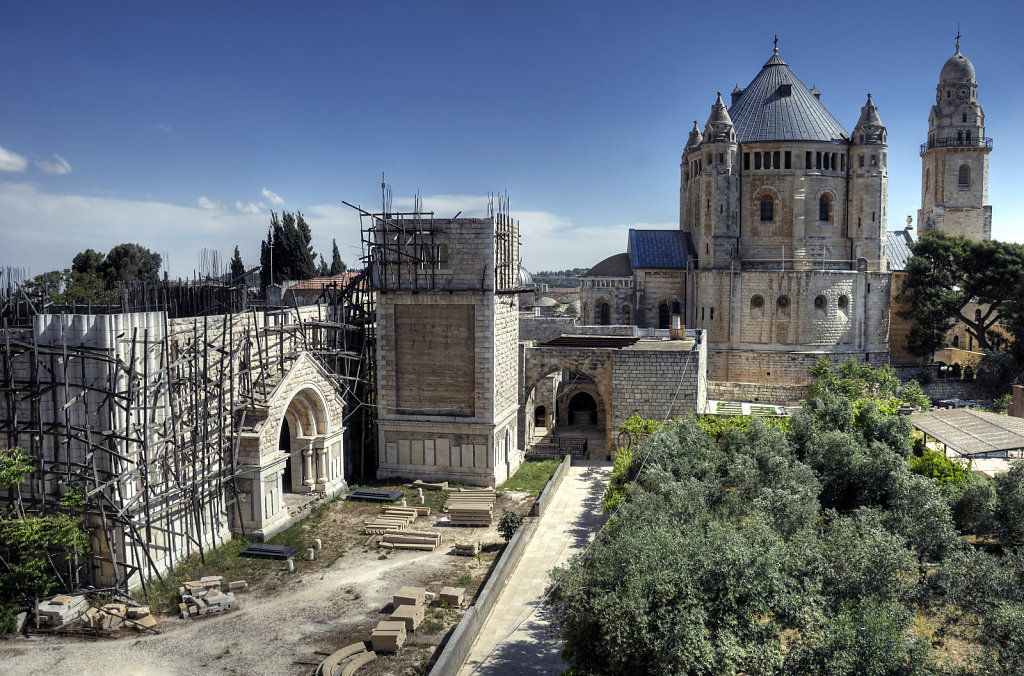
[[581, 42, 991, 385]]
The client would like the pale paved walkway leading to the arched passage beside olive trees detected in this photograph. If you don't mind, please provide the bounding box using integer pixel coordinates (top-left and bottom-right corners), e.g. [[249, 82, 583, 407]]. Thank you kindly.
[[459, 460, 611, 676]]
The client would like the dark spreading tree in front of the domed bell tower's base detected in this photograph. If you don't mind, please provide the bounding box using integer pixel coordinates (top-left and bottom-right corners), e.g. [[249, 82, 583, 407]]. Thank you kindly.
[[898, 230, 1024, 355]]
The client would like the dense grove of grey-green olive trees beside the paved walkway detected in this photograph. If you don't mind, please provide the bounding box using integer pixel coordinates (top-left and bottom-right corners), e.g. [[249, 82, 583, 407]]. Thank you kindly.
[[548, 365, 1024, 675]]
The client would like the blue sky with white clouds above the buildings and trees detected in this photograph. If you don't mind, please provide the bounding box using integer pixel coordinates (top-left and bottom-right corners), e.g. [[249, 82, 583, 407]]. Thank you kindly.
[[0, 0, 1024, 276]]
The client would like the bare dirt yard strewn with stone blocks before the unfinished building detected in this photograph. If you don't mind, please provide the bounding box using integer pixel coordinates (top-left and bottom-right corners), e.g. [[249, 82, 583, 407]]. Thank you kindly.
[[0, 487, 532, 676]]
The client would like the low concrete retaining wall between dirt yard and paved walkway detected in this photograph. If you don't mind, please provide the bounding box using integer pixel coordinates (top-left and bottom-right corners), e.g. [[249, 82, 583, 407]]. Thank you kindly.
[[430, 456, 572, 676]]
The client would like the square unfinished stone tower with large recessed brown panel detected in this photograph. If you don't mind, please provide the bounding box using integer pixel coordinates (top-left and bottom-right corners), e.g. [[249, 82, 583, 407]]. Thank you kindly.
[[374, 214, 522, 485]]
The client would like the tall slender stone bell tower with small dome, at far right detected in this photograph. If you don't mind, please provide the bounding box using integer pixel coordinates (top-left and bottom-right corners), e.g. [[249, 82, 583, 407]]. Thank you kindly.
[[918, 34, 992, 240]]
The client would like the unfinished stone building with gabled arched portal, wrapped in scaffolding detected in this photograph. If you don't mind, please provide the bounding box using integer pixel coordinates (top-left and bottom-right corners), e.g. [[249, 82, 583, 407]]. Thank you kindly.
[[0, 276, 374, 590]]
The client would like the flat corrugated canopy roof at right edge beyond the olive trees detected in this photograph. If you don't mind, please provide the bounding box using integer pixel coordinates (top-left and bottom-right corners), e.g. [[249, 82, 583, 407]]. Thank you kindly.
[[910, 409, 1024, 456]]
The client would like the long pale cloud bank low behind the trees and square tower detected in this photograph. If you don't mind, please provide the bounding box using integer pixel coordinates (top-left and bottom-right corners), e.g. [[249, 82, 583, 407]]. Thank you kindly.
[[0, 182, 643, 277]]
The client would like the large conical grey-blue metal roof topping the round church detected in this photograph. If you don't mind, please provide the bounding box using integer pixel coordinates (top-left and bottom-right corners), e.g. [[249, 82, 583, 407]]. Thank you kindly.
[[729, 54, 850, 143]]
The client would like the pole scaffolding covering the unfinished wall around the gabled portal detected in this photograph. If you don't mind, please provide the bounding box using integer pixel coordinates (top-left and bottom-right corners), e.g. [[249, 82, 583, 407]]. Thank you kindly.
[[0, 268, 376, 594]]
